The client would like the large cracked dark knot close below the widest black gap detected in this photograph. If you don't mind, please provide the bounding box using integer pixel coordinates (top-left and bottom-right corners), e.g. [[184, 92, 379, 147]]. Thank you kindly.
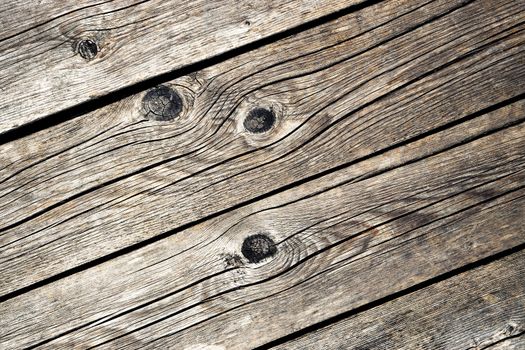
[[142, 85, 182, 121]]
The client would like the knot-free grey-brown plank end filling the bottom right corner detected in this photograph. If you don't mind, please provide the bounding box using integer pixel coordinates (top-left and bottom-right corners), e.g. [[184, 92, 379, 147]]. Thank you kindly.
[[275, 251, 525, 350]]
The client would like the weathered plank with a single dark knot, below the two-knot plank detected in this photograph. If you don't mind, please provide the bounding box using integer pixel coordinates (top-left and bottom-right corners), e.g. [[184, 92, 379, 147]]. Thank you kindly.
[[0, 113, 525, 349]]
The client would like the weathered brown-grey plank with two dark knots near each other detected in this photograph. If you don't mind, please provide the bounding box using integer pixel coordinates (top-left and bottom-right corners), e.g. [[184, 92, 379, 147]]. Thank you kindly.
[[0, 0, 525, 295]]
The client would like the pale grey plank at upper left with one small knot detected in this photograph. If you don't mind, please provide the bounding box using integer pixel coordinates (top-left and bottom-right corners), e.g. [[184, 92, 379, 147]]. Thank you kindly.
[[0, 0, 362, 133]]
